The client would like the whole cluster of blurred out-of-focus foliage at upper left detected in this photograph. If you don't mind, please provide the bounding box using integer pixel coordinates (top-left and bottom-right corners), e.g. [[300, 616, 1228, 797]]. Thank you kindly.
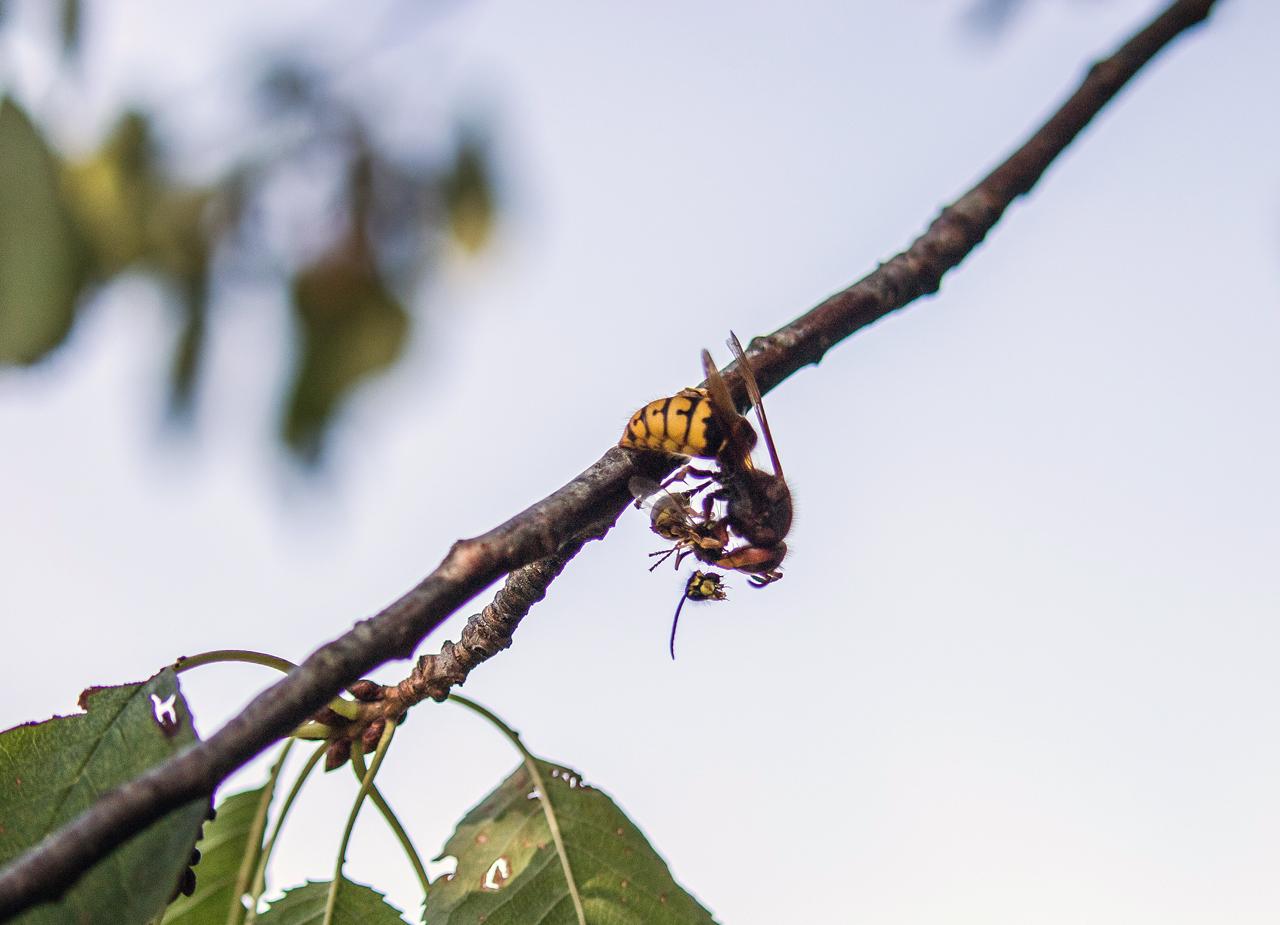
[[0, 11, 495, 463]]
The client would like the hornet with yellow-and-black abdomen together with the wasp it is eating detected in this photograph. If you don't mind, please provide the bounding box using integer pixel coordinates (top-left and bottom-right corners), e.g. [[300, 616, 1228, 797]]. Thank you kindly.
[[618, 331, 791, 656]]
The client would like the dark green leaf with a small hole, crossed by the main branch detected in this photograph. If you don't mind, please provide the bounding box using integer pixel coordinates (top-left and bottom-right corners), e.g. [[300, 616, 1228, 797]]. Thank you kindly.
[[0, 668, 209, 925]]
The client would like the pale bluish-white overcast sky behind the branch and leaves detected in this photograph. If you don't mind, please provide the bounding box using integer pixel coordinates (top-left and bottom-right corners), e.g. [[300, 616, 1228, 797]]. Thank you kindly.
[[0, 0, 1280, 925]]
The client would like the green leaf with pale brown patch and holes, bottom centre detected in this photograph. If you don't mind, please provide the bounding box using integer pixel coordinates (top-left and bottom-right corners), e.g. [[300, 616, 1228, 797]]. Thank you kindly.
[[422, 761, 714, 925]]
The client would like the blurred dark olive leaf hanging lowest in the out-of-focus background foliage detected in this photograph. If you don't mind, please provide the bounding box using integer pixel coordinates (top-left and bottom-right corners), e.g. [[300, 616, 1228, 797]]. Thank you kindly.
[[284, 234, 408, 462]]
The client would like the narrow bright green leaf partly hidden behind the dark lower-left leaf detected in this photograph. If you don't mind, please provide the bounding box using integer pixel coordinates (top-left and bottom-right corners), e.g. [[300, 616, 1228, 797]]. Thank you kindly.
[[164, 787, 266, 925]]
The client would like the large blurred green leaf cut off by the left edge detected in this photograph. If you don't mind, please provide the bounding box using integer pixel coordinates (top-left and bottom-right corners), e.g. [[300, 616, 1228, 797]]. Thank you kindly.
[[0, 96, 88, 365]]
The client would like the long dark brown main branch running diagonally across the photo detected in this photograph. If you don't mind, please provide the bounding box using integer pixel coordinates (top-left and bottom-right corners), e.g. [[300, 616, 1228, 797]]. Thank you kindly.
[[0, 0, 1215, 921]]
